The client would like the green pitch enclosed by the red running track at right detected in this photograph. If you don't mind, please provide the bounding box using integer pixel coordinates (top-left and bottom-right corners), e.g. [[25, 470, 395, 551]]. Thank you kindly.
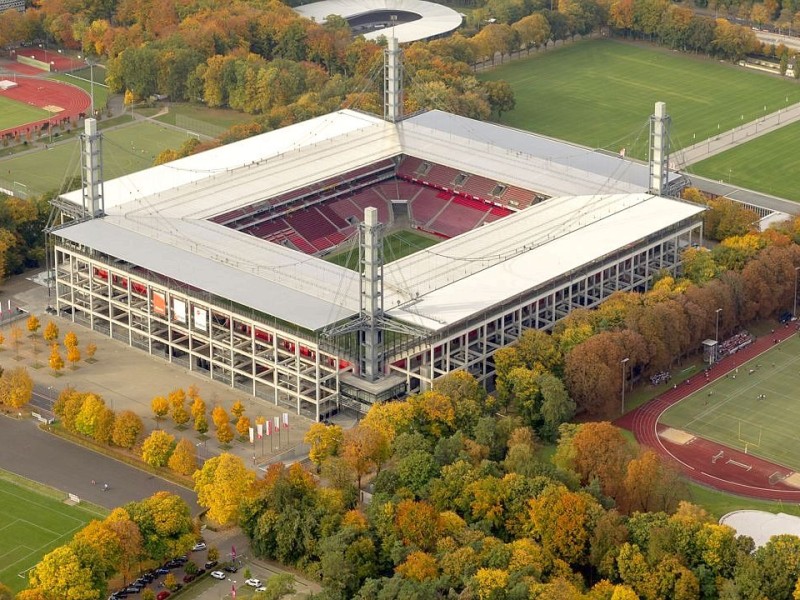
[[660, 335, 800, 471]]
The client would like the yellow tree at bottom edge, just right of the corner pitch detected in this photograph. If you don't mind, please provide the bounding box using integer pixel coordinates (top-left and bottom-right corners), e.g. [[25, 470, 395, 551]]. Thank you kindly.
[[28, 546, 99, 600]]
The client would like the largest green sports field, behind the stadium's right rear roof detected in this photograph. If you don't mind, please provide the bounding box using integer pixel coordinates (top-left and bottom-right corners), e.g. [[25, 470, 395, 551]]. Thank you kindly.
[[480, 39, 800, 158]]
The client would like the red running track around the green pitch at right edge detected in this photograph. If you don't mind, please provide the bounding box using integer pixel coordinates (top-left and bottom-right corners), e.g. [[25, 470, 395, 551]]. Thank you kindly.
[[615, 326, 800, 502]]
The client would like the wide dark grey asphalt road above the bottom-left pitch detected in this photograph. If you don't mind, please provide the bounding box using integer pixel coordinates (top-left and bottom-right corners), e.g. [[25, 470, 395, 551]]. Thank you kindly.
[[0, 418, 200, 515]]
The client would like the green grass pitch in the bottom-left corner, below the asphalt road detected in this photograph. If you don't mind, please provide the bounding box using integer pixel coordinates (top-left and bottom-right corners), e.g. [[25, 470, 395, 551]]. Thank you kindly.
[[0, 478, 102, 592]]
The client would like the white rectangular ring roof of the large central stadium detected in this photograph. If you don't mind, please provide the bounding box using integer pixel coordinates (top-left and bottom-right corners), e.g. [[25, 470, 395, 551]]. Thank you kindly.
[[55, 110, 702, 330]]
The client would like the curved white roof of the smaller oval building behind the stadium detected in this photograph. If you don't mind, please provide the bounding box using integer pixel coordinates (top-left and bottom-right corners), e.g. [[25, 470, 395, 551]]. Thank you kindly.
[[295, 0, 463, 44]]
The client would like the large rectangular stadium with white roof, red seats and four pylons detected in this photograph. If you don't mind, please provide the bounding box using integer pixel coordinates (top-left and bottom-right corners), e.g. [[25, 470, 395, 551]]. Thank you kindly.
[[49, 41, 703, 420]]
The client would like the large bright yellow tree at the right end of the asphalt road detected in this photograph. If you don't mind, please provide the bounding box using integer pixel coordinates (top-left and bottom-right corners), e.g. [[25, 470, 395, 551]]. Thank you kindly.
[[192, 452, 255, 525]]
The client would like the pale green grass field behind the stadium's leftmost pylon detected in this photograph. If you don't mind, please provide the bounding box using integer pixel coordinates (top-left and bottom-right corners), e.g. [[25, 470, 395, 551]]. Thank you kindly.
[[0, 121, 198, 194]]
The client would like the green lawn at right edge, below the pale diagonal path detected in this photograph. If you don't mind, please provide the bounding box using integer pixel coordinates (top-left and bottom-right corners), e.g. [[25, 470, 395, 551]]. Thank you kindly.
[[689, 122, 800, 202]]
